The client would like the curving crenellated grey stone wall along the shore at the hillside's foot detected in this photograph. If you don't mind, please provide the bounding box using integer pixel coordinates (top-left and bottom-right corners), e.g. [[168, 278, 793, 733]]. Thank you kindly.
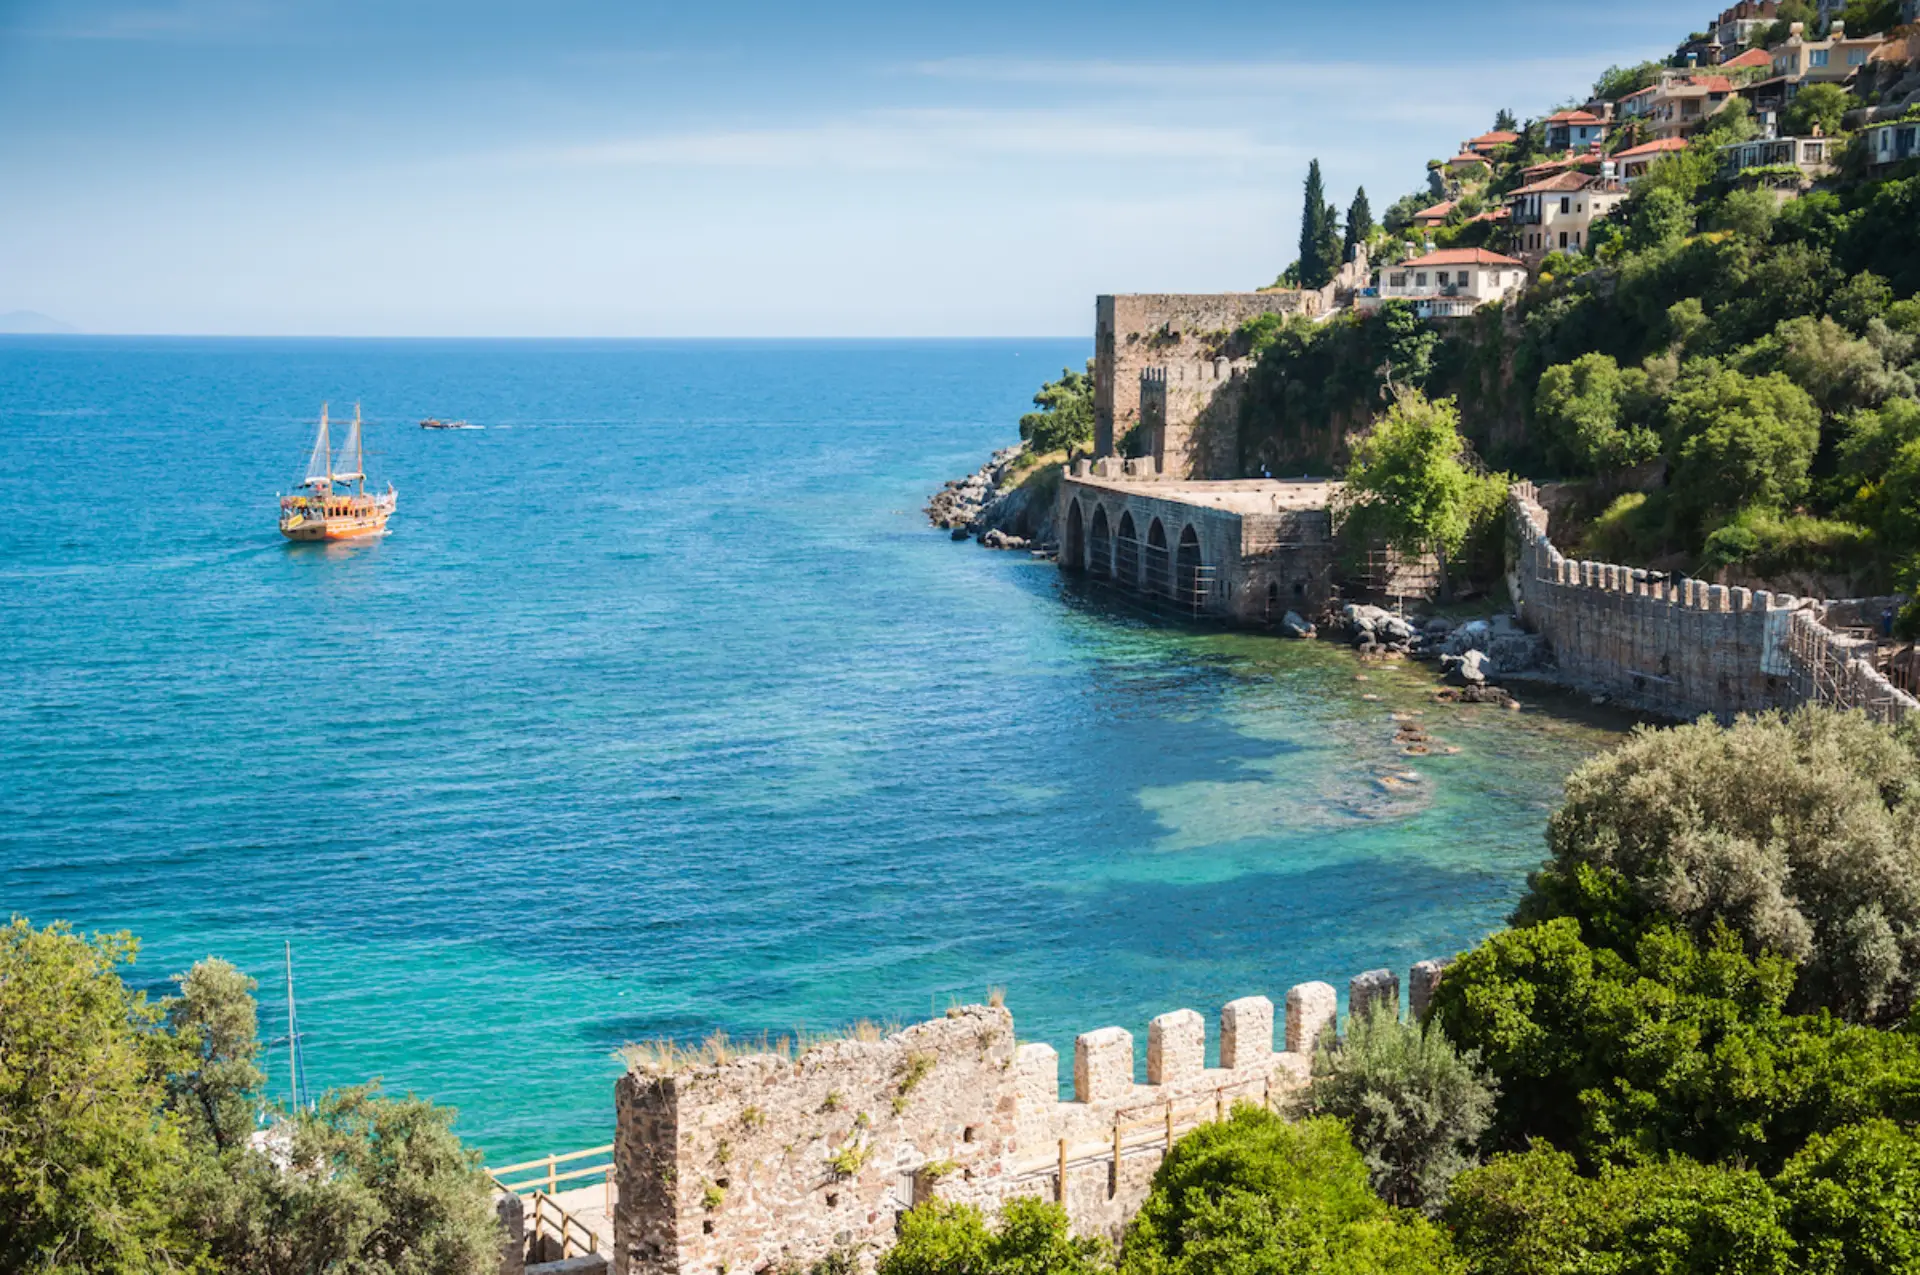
[[1507, 482, 1920, 720]]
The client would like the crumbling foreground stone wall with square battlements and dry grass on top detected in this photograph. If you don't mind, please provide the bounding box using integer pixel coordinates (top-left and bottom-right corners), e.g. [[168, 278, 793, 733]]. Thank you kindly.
[[614, 960, 1442, 1275]]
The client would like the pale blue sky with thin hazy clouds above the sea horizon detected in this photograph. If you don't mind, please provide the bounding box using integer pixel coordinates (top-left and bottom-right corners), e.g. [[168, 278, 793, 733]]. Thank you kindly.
[[0, 0, 1681, 336]]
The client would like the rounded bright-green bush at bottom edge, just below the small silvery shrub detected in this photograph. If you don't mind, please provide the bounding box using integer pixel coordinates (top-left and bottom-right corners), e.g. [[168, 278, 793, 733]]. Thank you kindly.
[[1121, 1104, 1463, 1275]]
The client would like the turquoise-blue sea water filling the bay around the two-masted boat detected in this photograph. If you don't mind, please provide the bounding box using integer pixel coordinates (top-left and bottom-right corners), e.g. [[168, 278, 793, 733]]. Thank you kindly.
[[0, 338, 1609, 1162]]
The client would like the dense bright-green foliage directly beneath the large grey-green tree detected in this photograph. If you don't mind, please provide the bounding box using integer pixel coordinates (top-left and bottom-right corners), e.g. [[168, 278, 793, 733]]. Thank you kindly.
[[1434, 917, 1920, 1171]]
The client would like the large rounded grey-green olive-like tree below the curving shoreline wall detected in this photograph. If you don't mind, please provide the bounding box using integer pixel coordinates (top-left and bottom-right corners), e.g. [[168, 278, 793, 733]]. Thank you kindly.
[[1519, 709, 1920, 1022]]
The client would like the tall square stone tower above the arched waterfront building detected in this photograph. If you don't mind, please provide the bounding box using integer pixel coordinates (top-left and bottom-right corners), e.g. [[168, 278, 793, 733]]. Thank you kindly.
[[1092, 290, 1325, 466]]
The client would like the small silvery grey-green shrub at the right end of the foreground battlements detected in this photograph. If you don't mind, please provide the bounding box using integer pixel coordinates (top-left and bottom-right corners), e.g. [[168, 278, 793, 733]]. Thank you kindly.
[[1302, 1006, 1498, 1214]]
